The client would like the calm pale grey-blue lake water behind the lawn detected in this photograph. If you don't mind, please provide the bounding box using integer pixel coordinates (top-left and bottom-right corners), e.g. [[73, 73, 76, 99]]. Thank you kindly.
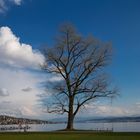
[[0, 122, 140, 132]]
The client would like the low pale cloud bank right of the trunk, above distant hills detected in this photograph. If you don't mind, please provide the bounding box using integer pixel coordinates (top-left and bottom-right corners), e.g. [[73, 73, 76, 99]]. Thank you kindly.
[[78, 102, 140, 117]]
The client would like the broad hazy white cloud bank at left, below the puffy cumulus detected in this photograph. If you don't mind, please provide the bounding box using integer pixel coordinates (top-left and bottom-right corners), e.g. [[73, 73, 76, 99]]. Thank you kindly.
[[0, 67, 44, 117]]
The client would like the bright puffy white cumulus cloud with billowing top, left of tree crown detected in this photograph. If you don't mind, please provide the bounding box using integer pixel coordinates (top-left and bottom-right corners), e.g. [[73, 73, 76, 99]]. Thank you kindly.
[[0, 27, 44, 68]]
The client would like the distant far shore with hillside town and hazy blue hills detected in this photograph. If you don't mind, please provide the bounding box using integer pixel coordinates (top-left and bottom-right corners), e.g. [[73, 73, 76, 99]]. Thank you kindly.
[[0, 115, 140, 125]]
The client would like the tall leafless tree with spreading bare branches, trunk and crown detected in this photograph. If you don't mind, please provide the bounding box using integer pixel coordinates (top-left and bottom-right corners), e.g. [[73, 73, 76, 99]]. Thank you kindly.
[[43, 24, 116, 130]]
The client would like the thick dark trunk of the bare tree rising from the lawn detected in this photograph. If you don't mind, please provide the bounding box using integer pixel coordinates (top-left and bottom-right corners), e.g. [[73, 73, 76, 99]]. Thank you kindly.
[[66, 98, 74, 130]]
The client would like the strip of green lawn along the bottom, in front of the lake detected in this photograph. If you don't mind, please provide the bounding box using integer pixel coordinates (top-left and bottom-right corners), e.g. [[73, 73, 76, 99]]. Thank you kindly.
[[0, 132, 140, 140]]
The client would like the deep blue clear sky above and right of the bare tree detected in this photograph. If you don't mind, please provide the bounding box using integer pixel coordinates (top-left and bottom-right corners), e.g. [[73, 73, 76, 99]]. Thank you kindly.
[[0, 0, 140, 118]]
